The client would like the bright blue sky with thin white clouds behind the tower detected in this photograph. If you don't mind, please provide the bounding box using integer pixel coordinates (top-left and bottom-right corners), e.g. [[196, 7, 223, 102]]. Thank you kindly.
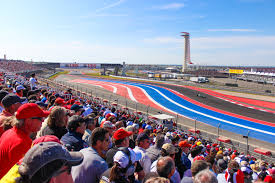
[[0, 0, 275, 66]]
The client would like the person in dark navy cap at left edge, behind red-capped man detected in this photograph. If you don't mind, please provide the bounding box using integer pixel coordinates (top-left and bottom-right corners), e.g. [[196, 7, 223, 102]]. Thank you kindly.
[[0, 94, 26, 137]]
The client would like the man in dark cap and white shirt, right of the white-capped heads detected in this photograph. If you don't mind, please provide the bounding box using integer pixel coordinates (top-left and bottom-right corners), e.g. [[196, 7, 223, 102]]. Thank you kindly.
[[135, 133, 151, 175]]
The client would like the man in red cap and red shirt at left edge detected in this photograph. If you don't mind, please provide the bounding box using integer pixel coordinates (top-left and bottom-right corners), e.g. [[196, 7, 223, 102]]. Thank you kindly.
[[0, 103, 49, 179]]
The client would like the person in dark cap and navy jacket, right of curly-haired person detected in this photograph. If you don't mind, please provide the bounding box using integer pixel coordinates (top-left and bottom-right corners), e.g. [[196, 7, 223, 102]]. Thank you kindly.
[[61, 115, 89, 151]]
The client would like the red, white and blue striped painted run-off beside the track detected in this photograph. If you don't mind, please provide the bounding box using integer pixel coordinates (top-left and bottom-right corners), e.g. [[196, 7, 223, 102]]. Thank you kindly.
[[69, 78, 275, 144]]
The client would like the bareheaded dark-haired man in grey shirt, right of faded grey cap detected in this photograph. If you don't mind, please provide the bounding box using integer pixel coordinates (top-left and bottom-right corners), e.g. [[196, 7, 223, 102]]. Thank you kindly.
[[72, 128, 110, 183]]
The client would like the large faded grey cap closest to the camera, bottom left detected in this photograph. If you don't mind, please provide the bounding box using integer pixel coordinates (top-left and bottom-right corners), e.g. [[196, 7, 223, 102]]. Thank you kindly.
[[18, 142, 83, 178]]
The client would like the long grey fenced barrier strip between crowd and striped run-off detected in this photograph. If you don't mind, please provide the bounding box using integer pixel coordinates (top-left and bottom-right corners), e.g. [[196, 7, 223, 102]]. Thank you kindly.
[[39, 78, 275, 163]]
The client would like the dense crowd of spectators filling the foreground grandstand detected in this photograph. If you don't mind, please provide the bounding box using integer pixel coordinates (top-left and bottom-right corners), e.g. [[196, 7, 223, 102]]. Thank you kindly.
[[0, 71, 275, 183]]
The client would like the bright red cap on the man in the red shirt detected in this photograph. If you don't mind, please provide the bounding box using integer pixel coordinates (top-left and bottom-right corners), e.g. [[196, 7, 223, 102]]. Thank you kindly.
[[15, 103, 50, 119]]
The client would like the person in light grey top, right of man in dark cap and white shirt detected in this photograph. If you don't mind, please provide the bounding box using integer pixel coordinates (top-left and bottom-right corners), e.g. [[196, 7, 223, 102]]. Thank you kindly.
[[146, 134, 164, 163]]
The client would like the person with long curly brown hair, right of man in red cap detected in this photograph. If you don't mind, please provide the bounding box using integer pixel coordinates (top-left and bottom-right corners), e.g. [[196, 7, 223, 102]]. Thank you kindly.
[[41, 107, 68, 139]]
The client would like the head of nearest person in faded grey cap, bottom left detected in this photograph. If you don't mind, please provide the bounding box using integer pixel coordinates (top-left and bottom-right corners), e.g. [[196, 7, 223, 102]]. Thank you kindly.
[[7, 142, 83, 182]]
